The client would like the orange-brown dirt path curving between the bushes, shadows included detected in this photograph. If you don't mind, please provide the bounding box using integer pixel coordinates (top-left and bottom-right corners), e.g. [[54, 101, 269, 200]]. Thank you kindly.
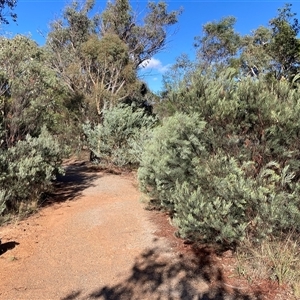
[[0, 164, 282, 300]]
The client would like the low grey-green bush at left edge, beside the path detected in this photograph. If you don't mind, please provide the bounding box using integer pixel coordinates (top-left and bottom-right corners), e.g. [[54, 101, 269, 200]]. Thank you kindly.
[[0, 128, 66, 213]]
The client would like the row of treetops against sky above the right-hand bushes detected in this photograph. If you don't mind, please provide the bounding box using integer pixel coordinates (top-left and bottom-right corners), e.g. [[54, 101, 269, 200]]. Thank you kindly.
[[191, 4, 300, 81]]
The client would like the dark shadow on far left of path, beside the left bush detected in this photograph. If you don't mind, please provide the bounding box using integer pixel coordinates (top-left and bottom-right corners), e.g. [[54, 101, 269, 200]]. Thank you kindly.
[[43, 162, 100, 206]]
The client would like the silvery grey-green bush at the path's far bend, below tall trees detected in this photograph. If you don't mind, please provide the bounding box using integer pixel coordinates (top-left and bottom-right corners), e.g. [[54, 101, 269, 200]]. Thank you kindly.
[[83, 105, 157, 166]]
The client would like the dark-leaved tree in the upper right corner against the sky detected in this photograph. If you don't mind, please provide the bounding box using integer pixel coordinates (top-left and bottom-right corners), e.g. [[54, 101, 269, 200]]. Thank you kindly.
[[241, 4, 300, 80]]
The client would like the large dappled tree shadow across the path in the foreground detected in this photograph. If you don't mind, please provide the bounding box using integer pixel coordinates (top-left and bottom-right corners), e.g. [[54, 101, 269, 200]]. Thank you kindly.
[[62, 248, 263, 300]]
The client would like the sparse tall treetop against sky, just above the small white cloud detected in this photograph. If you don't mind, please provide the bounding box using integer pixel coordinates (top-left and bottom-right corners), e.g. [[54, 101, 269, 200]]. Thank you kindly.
[[100, 0, 182, 68]]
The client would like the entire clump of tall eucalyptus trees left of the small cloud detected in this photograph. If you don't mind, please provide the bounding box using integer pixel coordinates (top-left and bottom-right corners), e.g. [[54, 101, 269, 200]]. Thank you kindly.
[[46, 0, 179, 123]]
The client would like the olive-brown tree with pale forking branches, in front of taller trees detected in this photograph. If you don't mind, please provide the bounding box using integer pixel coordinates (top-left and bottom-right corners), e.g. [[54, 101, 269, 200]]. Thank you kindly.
[[81, 33, 140, 116]]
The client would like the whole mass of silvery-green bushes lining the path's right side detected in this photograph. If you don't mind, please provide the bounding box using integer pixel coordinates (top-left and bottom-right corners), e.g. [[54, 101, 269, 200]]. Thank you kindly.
[[138, 113, 300, 245]]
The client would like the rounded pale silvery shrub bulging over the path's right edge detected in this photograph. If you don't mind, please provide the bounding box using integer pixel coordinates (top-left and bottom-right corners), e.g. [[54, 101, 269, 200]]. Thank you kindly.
[[138, 113, 209, 210]]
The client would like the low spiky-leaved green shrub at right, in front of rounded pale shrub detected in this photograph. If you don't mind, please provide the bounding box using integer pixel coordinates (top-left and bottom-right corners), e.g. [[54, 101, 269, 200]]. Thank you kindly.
[[172, 155, 251, 244]]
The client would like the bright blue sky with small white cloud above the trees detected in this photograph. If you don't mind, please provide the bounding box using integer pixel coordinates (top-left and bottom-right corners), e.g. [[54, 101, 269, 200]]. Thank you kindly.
[[0, 0, 300, 91]]
